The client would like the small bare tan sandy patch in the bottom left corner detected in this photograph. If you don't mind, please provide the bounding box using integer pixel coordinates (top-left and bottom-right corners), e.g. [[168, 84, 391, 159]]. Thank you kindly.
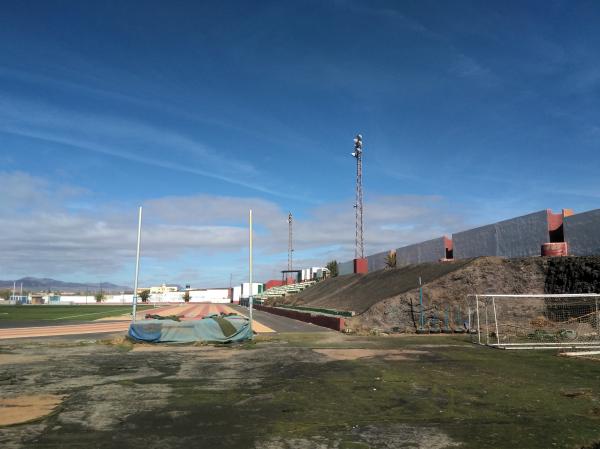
[[0, 394, 63, 426]]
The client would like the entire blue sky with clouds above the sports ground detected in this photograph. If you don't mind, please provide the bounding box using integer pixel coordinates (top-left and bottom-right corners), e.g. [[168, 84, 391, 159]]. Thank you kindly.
[[0, 0, 600, 286]]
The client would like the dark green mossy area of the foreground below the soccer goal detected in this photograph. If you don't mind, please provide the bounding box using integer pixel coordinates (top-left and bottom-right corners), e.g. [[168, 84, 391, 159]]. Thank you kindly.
[[278, 337, 600, 448]]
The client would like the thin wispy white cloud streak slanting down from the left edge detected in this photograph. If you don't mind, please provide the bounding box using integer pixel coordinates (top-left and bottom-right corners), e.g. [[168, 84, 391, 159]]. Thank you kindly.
[[0, 97, 311, 202]]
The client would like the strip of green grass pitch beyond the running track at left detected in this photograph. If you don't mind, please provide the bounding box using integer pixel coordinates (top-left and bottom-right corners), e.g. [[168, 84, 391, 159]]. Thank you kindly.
[[0, 304, 153, 321]]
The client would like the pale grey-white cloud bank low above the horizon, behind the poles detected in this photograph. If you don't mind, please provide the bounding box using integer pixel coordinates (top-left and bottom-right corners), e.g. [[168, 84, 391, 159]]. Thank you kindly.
[[0, 172, 462, 285]]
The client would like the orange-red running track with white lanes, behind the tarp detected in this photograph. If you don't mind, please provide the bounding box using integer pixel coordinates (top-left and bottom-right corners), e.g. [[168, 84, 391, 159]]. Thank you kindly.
[[0, 303, 275, 340]]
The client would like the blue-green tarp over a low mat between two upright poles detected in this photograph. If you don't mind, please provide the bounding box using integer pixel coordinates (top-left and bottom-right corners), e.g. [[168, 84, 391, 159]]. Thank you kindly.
[[129, 315, 252, 343]]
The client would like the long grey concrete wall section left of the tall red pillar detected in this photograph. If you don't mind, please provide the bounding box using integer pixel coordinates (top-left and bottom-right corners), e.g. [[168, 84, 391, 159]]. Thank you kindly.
[[452, 210, 550, 259]]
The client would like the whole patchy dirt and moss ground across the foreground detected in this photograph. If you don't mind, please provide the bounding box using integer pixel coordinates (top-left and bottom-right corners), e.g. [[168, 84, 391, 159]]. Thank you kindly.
[[0, 332, 600, 449]]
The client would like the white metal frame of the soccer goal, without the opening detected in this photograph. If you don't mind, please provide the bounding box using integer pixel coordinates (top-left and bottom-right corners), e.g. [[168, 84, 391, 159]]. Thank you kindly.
[[467, 293, 600, 350]]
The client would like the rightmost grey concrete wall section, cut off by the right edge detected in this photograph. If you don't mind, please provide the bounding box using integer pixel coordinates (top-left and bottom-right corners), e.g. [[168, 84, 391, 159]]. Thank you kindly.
[[563, 209, 600, 256]]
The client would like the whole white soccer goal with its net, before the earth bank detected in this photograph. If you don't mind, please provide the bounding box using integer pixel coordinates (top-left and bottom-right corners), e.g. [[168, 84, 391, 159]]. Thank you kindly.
[[467, 293, 600, 349]]
